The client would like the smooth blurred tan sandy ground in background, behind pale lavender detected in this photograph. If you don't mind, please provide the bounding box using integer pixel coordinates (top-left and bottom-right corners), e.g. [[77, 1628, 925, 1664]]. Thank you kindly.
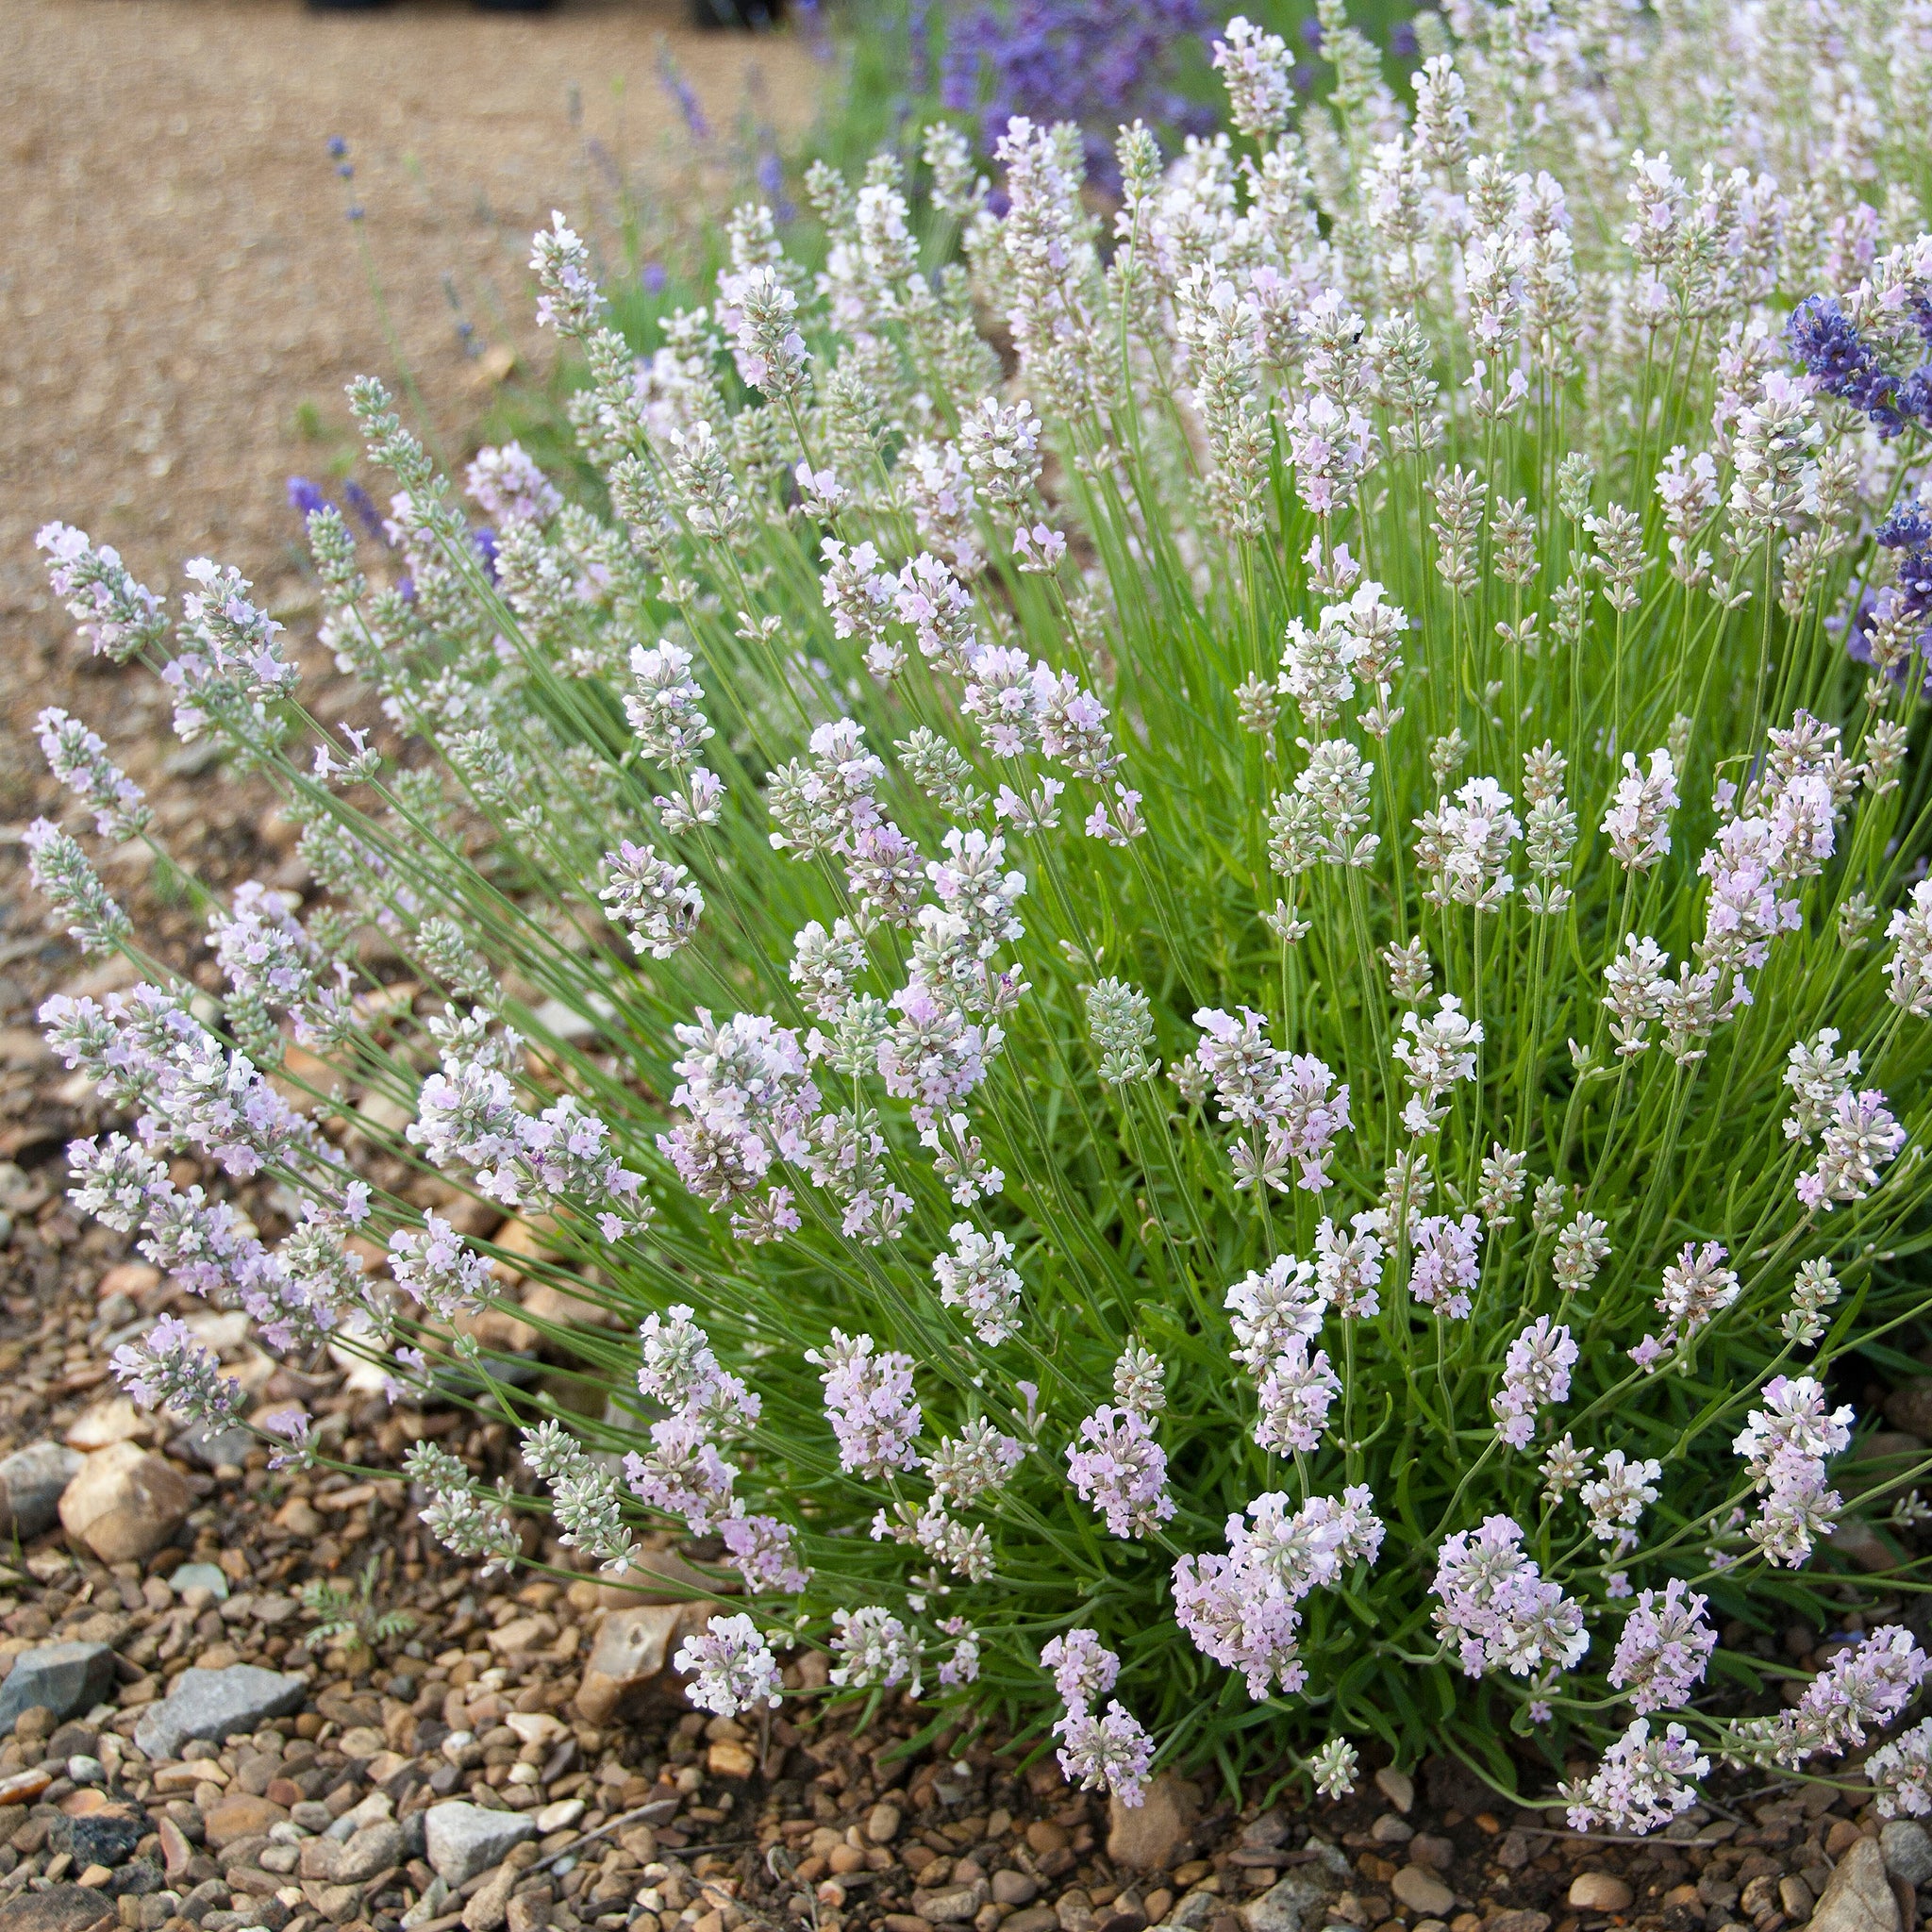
[[0, 0, 819, 618]]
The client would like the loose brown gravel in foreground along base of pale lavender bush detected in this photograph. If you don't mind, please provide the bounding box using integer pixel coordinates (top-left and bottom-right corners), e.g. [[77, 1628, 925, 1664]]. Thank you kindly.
[[0, 1190, 1932, 1932]]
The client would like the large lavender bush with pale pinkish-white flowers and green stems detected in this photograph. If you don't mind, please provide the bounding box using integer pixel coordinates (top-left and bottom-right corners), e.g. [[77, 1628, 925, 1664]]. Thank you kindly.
[[33, 4, 1932, 1832]]
